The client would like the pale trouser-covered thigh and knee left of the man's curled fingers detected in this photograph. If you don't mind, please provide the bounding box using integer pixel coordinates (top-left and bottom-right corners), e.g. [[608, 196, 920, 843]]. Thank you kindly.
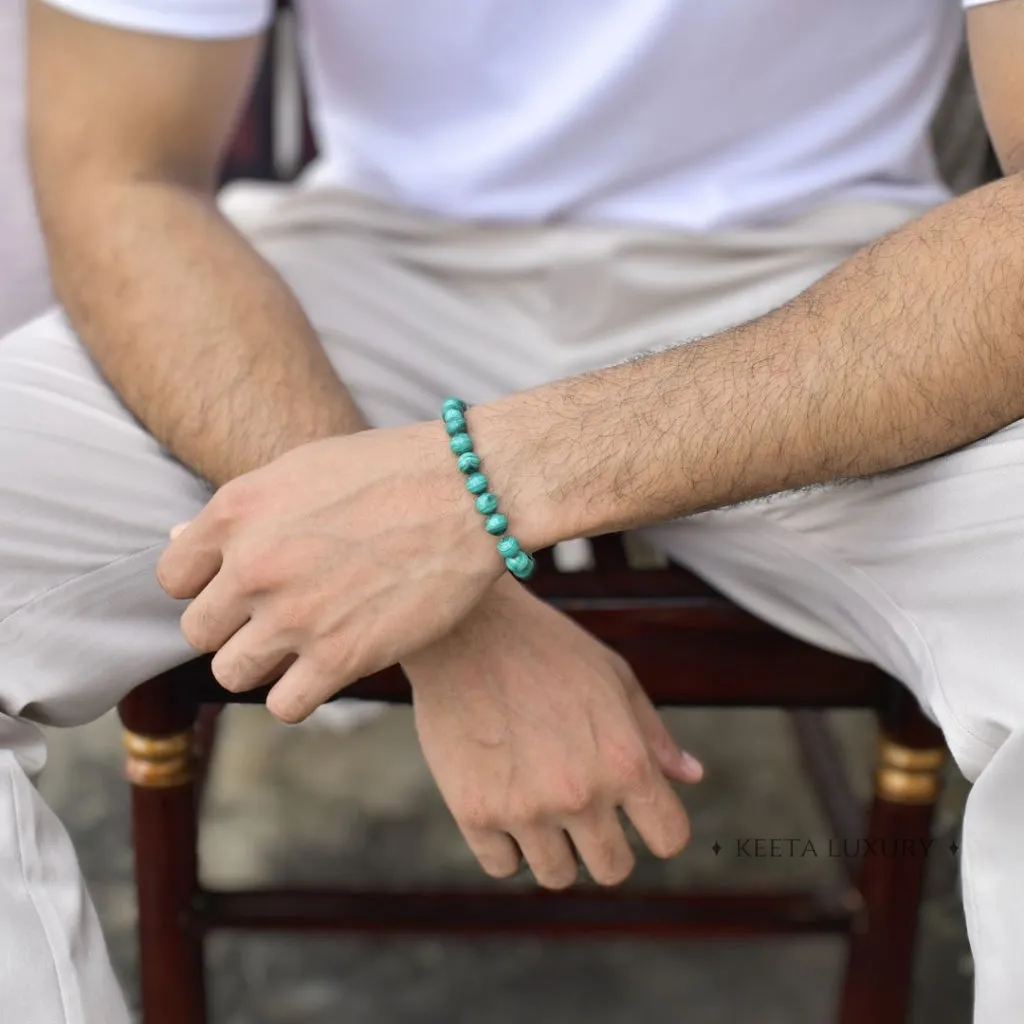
[[0, 312, 209, 723]]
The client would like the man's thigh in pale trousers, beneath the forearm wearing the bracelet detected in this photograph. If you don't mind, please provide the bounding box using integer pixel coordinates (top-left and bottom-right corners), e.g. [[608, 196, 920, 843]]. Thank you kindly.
[[650, 422, 1024, 778]]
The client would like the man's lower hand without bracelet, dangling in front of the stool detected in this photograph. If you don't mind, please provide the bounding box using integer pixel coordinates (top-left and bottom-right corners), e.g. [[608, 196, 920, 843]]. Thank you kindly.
[[403, 578, 701, 889]]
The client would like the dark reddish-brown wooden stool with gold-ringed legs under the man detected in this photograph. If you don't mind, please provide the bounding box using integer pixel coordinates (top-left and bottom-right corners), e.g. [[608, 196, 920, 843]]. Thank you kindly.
[[120, 538, 945, 1024]]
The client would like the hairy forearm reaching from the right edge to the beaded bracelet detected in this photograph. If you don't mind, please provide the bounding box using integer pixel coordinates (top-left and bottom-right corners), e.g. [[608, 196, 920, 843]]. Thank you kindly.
[[472, 175, 1024, 546]]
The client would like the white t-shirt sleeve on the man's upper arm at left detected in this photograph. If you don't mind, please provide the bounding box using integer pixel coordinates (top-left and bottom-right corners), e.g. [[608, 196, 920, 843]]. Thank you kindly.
[[38, 0, 273, 39]]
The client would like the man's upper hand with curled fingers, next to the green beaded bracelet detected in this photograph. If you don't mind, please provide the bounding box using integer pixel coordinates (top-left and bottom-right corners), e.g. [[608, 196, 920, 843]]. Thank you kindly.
[[158, 422, 504, 722]]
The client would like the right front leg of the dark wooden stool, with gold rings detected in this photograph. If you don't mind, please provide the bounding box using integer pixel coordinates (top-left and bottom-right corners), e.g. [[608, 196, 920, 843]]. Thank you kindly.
[[840, 707, 946, 1024]]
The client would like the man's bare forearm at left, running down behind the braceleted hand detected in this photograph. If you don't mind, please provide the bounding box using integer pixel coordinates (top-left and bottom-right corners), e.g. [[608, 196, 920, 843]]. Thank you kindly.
[[44, 182, 364, 484]]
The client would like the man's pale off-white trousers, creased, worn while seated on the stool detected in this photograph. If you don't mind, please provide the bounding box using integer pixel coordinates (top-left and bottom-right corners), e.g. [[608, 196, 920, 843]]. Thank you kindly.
[[0, 189, 1024, 1024]]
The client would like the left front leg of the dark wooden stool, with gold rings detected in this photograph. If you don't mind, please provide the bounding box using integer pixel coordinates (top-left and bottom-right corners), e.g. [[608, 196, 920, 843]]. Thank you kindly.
[[120, 678, 207, 1024]]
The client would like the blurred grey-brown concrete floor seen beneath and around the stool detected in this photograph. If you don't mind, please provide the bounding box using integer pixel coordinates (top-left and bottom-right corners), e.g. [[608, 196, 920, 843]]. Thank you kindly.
[[42, 709, 971, 1024]]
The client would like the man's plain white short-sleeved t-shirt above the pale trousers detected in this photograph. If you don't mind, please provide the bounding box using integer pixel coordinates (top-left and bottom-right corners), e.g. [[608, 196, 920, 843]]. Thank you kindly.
[[50, 0, 999, 230]]
